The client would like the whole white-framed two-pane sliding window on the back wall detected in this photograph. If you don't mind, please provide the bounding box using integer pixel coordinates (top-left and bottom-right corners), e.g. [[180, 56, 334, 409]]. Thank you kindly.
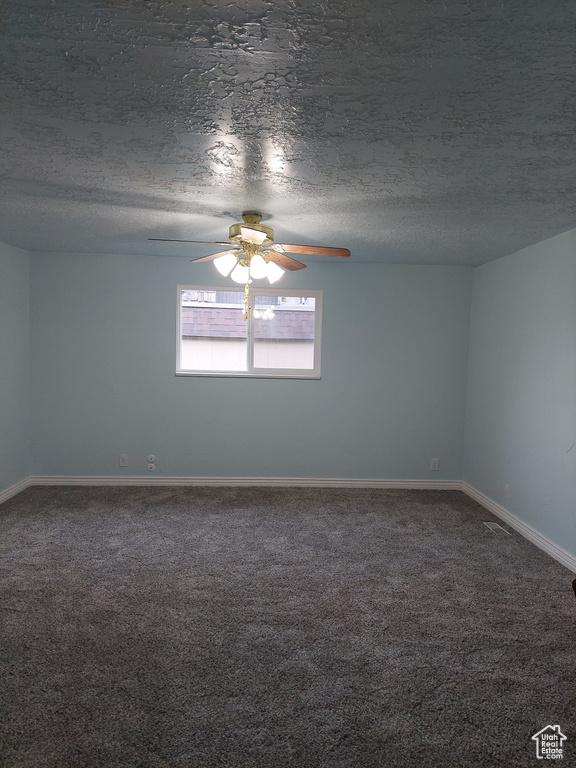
[[176, 286, 322, 379]]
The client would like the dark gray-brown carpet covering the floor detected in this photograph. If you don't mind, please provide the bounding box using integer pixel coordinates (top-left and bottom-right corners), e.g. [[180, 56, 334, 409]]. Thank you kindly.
[[0, 487, 576, 768]]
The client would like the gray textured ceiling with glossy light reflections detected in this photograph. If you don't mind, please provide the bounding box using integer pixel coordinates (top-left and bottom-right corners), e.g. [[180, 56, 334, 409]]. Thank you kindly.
[[0, 0, 576, 264]]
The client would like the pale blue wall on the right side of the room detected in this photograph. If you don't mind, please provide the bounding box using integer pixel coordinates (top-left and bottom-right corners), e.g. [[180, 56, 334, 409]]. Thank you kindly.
[[463, 230, 576, 553]]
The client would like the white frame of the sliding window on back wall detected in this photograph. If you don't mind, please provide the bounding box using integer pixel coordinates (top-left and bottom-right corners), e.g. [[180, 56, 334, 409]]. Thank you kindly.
[[176, 285, 322, 379]]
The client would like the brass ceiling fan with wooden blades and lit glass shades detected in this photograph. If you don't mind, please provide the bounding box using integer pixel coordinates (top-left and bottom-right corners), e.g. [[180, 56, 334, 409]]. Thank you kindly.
[[150, 211, 350, 318]]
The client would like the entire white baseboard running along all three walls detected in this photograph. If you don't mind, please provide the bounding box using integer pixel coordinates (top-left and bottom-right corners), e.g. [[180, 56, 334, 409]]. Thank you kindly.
[[0, 475, 576, 573]]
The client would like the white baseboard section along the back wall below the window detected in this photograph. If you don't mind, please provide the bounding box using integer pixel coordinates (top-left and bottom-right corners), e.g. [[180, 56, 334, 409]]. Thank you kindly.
[[28, 475, 462, 491]]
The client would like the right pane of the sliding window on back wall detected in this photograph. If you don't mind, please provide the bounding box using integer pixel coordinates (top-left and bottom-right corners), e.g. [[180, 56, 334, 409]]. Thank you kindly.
[[253, 295, 316, 370]]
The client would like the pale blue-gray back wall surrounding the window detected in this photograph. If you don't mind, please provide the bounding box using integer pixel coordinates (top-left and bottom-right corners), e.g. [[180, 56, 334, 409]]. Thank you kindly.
[[31, 254, 472, 480]]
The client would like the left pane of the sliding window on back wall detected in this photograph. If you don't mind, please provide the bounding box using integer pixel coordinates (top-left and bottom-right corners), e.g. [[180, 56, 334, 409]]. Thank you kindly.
[[180, 289, 248, 371]]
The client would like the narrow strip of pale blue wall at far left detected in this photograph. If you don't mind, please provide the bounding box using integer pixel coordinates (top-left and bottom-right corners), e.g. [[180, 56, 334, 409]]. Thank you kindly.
[[0, 243, 30, 491]]
